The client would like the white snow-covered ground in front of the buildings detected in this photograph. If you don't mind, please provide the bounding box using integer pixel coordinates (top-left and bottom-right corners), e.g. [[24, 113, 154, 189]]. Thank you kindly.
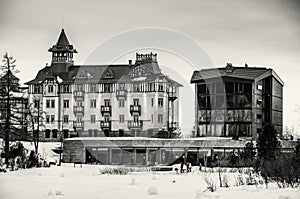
[[0, 164, 300, 199]]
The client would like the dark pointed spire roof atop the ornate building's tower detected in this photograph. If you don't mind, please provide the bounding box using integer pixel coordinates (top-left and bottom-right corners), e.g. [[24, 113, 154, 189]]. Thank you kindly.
[[48, 29, 77, 53]]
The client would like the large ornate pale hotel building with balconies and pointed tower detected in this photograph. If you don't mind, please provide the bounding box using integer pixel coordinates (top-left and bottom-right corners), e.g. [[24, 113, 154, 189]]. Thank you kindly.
[[27, 29, 181, 141]]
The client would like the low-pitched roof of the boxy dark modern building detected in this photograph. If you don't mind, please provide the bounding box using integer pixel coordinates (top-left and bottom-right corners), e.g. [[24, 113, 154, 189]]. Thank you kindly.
[[191, 64, 283, 84]]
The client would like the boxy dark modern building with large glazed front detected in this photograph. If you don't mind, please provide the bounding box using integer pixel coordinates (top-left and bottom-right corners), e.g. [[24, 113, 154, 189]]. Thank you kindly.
[[191, 63, 283, 138]]
